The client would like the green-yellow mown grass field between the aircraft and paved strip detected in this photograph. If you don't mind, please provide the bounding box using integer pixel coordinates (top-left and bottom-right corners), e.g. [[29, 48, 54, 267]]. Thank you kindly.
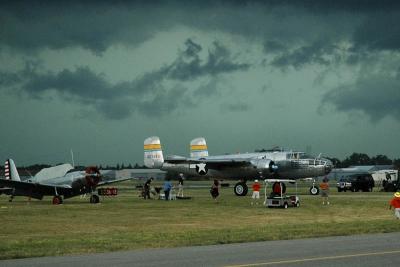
[[0, 181, 400, 259]]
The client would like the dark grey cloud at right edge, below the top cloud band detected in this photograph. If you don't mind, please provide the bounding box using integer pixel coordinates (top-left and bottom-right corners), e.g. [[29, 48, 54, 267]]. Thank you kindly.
[[322, 73, 400, 121]]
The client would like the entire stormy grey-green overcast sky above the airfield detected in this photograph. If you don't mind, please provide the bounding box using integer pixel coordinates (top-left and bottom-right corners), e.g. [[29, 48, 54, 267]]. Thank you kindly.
[[0, 0, 400, 165]]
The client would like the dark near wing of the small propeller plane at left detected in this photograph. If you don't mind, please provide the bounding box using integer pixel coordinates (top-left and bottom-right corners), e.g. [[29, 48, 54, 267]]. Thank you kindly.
[[0, 179, 72, 195]]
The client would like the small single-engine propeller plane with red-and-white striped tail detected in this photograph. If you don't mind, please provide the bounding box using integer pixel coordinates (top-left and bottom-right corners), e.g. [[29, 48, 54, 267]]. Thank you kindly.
[[0, 159, 129, 205]]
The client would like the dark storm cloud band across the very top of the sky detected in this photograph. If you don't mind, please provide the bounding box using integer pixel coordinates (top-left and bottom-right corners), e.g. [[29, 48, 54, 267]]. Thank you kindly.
[[0, 0, 400, 62]]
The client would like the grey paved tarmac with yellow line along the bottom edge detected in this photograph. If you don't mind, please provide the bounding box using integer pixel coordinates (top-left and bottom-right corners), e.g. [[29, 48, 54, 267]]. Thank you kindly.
[[0, 232, 400, 267]]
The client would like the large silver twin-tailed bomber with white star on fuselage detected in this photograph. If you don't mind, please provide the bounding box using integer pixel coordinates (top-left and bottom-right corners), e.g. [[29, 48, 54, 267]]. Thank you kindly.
[[144, 136, 333, 196]]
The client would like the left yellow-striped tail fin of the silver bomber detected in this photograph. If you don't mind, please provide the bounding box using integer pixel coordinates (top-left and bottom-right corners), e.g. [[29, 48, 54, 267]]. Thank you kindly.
[[144, 136, 164, 168]]
